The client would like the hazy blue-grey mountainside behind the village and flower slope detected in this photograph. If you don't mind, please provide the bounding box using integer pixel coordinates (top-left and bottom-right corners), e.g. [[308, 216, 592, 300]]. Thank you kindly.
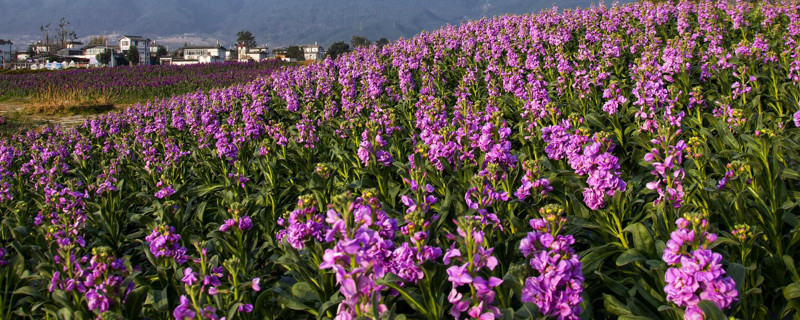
[[0, 0, 624, 47]]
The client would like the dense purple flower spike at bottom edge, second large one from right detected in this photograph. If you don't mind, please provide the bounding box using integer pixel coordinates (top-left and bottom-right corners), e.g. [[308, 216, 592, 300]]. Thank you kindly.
[[519, 205, 584, 319]]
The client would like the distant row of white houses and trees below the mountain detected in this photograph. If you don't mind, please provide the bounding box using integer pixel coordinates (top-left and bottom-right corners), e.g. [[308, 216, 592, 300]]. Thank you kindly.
[[0, 18, 344, 70]]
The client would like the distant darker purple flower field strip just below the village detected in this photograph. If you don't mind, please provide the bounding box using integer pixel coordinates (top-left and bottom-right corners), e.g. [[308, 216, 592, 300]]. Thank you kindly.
[[0, 61, 282, 104]]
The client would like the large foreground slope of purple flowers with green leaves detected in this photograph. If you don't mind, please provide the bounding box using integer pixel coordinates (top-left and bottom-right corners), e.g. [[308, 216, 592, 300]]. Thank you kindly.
[[0, 1, 800, 320]]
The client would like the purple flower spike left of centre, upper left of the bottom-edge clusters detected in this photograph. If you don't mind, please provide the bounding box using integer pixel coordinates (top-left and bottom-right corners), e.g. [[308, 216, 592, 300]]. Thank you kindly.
[[275, 195, 328, 250]]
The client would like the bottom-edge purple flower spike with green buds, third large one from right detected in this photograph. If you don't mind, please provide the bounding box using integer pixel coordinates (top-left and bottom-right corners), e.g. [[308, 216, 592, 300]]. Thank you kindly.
[[443, 216, 503, 319]]
